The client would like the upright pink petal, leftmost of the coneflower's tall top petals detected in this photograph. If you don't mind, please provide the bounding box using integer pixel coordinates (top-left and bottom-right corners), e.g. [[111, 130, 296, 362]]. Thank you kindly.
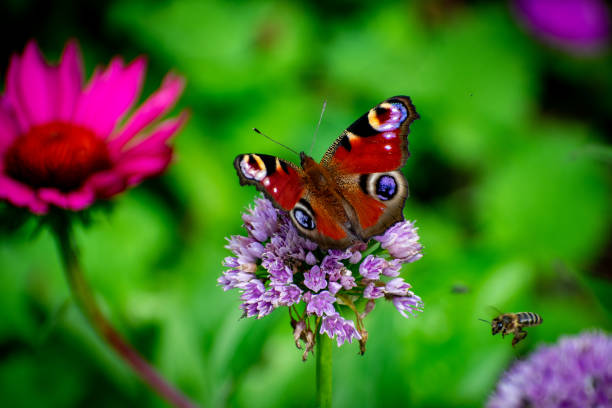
[[14, 41, 57, 125]]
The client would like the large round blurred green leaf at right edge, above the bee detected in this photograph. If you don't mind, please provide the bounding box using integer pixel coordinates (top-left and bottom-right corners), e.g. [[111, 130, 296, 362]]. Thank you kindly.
[[475, 125, 611, 262]]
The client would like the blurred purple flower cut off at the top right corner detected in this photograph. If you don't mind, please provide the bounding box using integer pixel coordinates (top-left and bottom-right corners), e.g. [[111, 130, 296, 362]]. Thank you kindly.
[[514, 0, 610, 54]]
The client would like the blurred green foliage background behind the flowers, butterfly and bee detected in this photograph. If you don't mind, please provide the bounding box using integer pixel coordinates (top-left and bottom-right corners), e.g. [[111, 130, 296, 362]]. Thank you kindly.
[[0, 0, 612, 408]]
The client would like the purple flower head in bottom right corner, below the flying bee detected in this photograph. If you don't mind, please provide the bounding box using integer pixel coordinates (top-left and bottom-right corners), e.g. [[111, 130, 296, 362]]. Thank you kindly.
[[487, 332, 612, 408]]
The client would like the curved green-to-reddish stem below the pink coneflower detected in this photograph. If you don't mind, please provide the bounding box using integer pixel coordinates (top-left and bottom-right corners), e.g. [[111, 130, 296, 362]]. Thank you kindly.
[[53, 217, 196, 408]]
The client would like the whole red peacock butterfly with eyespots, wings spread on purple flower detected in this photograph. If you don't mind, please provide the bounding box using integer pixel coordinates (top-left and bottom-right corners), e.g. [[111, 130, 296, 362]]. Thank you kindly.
[[234, 96, 419, 249]]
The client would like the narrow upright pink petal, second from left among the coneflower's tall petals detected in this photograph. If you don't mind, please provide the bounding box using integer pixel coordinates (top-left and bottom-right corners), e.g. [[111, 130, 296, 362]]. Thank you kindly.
[[57, 40, 83, 121]]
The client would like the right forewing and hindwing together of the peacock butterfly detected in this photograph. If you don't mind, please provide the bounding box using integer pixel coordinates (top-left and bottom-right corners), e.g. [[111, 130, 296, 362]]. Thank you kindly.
[[321, 96, 419, 241]]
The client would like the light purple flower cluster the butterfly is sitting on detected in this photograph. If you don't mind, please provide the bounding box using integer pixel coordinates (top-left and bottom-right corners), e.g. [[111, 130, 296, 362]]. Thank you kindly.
[[218, 197, 423, 355]]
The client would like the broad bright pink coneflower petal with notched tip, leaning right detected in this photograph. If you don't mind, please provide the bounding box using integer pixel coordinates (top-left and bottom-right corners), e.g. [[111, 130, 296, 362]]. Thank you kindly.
[[73, 58, 146, 138]]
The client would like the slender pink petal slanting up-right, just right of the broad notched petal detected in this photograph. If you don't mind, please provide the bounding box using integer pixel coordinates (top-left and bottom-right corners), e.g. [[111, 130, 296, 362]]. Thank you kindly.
[[109, 74, 185, 151]]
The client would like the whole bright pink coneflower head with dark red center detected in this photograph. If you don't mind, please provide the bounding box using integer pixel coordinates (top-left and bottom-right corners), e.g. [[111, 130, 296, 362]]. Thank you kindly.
[[0, 41, 187, 214]]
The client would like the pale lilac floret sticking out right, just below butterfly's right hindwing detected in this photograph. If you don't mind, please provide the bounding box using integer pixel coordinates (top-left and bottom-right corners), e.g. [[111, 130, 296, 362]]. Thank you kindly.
[[374, 221, 423, 262]]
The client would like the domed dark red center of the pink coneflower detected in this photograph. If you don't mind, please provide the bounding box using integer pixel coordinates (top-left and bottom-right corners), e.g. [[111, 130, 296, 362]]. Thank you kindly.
[[5, 122, 111, 192]]
